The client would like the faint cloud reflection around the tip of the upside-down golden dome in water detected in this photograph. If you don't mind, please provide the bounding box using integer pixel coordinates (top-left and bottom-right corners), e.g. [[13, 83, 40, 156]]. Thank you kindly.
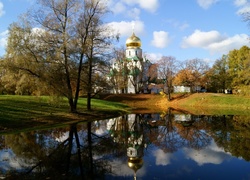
[[108, 159, 146, 177]]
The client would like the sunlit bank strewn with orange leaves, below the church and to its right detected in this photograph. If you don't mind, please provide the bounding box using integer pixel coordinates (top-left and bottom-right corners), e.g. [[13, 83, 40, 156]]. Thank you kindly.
[[103, 93, 250, 115]]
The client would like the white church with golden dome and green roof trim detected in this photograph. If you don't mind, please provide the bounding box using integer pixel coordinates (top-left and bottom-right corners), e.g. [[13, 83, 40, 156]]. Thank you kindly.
[[110, 32, 151, 94]]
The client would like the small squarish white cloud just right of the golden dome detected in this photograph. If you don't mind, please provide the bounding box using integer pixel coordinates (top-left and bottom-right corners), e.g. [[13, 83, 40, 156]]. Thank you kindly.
[[151, 31, 170, 48]]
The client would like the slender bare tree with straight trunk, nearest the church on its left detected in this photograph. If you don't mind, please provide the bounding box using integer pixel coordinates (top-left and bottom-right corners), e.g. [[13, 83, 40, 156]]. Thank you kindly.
[[78, 0, 117, 110]]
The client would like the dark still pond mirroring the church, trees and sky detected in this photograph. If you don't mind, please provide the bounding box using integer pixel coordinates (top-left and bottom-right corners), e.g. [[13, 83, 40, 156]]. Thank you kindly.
[[0, 109, 250, 179]]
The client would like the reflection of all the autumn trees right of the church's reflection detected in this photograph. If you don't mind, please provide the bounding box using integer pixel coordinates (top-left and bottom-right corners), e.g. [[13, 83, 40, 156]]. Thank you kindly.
[[148, 111, 250, 161]]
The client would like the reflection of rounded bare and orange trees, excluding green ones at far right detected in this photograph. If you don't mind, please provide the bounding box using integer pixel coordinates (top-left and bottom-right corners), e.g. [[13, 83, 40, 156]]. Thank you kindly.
[[145, 109, 211, 152]]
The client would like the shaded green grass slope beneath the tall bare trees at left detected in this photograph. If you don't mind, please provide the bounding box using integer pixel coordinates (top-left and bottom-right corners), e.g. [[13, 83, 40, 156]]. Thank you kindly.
[[0, 95, 129, 132]]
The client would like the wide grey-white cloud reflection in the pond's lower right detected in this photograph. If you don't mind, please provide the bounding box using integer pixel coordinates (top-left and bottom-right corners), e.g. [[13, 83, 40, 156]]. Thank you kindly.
[[183, 141, 231, 166]]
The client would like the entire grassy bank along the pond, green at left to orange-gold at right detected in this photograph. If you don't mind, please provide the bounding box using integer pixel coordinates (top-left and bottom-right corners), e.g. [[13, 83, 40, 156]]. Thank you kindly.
[[0, 93, 250, 133]]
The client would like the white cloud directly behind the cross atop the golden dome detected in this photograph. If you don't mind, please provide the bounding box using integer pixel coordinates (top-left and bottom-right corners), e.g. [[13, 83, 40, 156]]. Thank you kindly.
[[108, 21, 144, 37]]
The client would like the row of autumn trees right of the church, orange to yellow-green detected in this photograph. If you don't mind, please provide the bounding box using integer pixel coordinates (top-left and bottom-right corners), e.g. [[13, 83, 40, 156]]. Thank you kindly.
[[157, 46, 250, 95]]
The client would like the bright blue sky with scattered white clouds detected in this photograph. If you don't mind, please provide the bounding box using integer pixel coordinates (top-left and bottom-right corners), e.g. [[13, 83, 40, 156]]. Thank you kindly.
[[0, 0, 250, 64]]
